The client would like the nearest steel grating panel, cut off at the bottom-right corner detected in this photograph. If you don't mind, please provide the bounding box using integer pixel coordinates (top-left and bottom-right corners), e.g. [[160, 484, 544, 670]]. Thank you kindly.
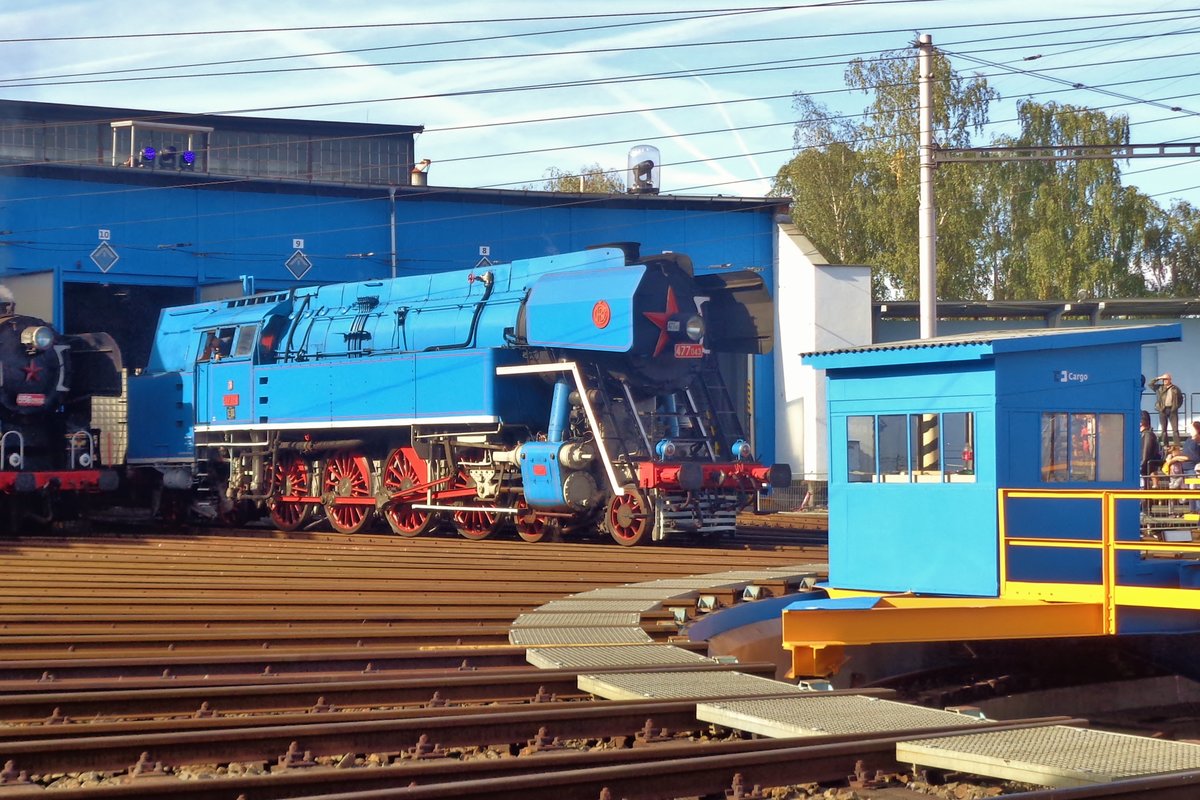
[[896, 726, 1200, 788]]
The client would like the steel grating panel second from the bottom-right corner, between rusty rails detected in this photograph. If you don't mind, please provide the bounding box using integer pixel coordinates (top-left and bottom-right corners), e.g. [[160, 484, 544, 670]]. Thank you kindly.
[[696, 692, 980, 738]]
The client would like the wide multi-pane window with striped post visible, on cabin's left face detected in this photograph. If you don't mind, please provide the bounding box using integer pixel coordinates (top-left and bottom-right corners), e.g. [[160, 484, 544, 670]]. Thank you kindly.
[[846, 411, 976, 483]]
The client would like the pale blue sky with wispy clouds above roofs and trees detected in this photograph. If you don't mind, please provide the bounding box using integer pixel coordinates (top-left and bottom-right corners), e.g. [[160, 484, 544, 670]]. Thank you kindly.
[[7, 0, 1200, 206]]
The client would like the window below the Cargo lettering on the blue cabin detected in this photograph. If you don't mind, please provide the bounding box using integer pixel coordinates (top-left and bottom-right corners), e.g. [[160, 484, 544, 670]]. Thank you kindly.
[[1042, 411, 1124, 483]]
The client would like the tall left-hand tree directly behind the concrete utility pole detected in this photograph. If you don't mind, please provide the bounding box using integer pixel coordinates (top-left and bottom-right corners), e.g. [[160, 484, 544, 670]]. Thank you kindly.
[[773, 50, 996, 297]]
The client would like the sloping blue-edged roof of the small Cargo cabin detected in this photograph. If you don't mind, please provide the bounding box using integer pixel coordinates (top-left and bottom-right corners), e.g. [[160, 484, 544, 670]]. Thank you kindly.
[[802, 323, 1183, 369]]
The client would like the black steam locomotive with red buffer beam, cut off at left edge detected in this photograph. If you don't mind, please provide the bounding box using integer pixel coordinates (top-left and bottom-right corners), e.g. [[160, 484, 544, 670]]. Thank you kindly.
[[0, 287, 121, 529]]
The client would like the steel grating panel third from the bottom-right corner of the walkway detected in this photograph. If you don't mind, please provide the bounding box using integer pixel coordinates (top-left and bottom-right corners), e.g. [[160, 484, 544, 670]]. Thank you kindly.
[[578, 672, 809, 700]]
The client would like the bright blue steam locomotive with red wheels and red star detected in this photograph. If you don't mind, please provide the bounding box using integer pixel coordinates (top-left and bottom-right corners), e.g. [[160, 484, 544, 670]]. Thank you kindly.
[[127, 243, 791, 545]]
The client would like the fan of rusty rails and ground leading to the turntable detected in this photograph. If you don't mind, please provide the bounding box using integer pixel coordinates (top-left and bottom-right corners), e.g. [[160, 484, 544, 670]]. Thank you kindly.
[[0, 531, 1200, 800]]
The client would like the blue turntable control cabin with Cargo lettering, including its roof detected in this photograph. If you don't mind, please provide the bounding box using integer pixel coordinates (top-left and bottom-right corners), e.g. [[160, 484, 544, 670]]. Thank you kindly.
[[804, 324, 1182, 597]]
